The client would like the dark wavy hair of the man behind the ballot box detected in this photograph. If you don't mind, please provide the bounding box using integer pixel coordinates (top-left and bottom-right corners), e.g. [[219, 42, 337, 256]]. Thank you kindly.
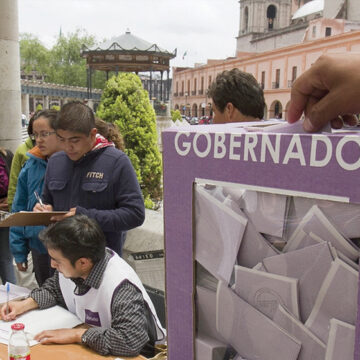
[[208, 68, 265, 119]]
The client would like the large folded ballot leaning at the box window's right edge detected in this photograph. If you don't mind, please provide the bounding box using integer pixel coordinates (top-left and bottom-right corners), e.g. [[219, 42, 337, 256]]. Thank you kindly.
[[305, 258, 359, 342]]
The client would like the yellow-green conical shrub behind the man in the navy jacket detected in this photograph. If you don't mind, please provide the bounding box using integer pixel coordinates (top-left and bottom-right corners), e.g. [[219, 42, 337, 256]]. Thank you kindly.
[[97, 73, 162, 208]]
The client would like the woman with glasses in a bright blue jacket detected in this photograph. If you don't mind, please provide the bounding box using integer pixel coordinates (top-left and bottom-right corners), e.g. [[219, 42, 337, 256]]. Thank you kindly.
[[10, 110, 60, 286]]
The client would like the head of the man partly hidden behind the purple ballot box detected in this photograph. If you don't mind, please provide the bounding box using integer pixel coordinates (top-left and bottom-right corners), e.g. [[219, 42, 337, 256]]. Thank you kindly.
[[208, 69, 265, 124]]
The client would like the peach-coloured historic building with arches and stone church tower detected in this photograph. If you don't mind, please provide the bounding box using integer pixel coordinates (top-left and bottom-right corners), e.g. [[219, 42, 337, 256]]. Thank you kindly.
[[172, 0, 360, 119]]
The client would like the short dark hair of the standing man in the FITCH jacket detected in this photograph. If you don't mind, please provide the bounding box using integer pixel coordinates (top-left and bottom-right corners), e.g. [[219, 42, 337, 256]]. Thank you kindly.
[[55, 101, 95, 135]]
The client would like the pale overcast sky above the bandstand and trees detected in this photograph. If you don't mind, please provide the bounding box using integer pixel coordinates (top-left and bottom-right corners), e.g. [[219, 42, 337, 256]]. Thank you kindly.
[[18, 0, 239, 66]]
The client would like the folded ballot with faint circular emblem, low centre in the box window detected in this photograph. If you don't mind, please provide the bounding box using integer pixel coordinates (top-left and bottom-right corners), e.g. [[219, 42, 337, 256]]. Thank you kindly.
[[233, 266, 299, 319]]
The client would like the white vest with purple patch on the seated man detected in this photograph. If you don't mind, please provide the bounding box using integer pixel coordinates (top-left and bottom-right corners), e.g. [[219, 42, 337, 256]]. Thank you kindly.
[[59, 250, 166, 340]]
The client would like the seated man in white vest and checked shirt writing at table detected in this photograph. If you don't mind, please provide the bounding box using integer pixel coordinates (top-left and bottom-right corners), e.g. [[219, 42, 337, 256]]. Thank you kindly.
[[1, 215, 165, 356]]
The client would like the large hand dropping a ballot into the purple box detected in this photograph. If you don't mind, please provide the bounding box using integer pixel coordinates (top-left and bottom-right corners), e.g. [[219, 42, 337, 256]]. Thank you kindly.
[[288, 53, 360, 132]]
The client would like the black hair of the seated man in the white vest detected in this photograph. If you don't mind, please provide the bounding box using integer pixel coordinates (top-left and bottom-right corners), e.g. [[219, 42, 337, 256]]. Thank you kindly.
[[39, 215, 105, 266]]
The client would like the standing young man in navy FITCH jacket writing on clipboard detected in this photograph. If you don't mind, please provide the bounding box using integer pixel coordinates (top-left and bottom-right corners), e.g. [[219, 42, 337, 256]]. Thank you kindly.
[[34, 101, 145, 255]]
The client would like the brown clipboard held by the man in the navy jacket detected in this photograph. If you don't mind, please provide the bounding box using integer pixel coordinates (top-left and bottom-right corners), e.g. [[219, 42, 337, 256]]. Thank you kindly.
[[0, 211, 67, 227]]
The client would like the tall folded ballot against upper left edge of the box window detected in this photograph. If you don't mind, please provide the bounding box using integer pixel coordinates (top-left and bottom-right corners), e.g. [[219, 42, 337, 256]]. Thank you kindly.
[[195, 186, 247, 282]]
